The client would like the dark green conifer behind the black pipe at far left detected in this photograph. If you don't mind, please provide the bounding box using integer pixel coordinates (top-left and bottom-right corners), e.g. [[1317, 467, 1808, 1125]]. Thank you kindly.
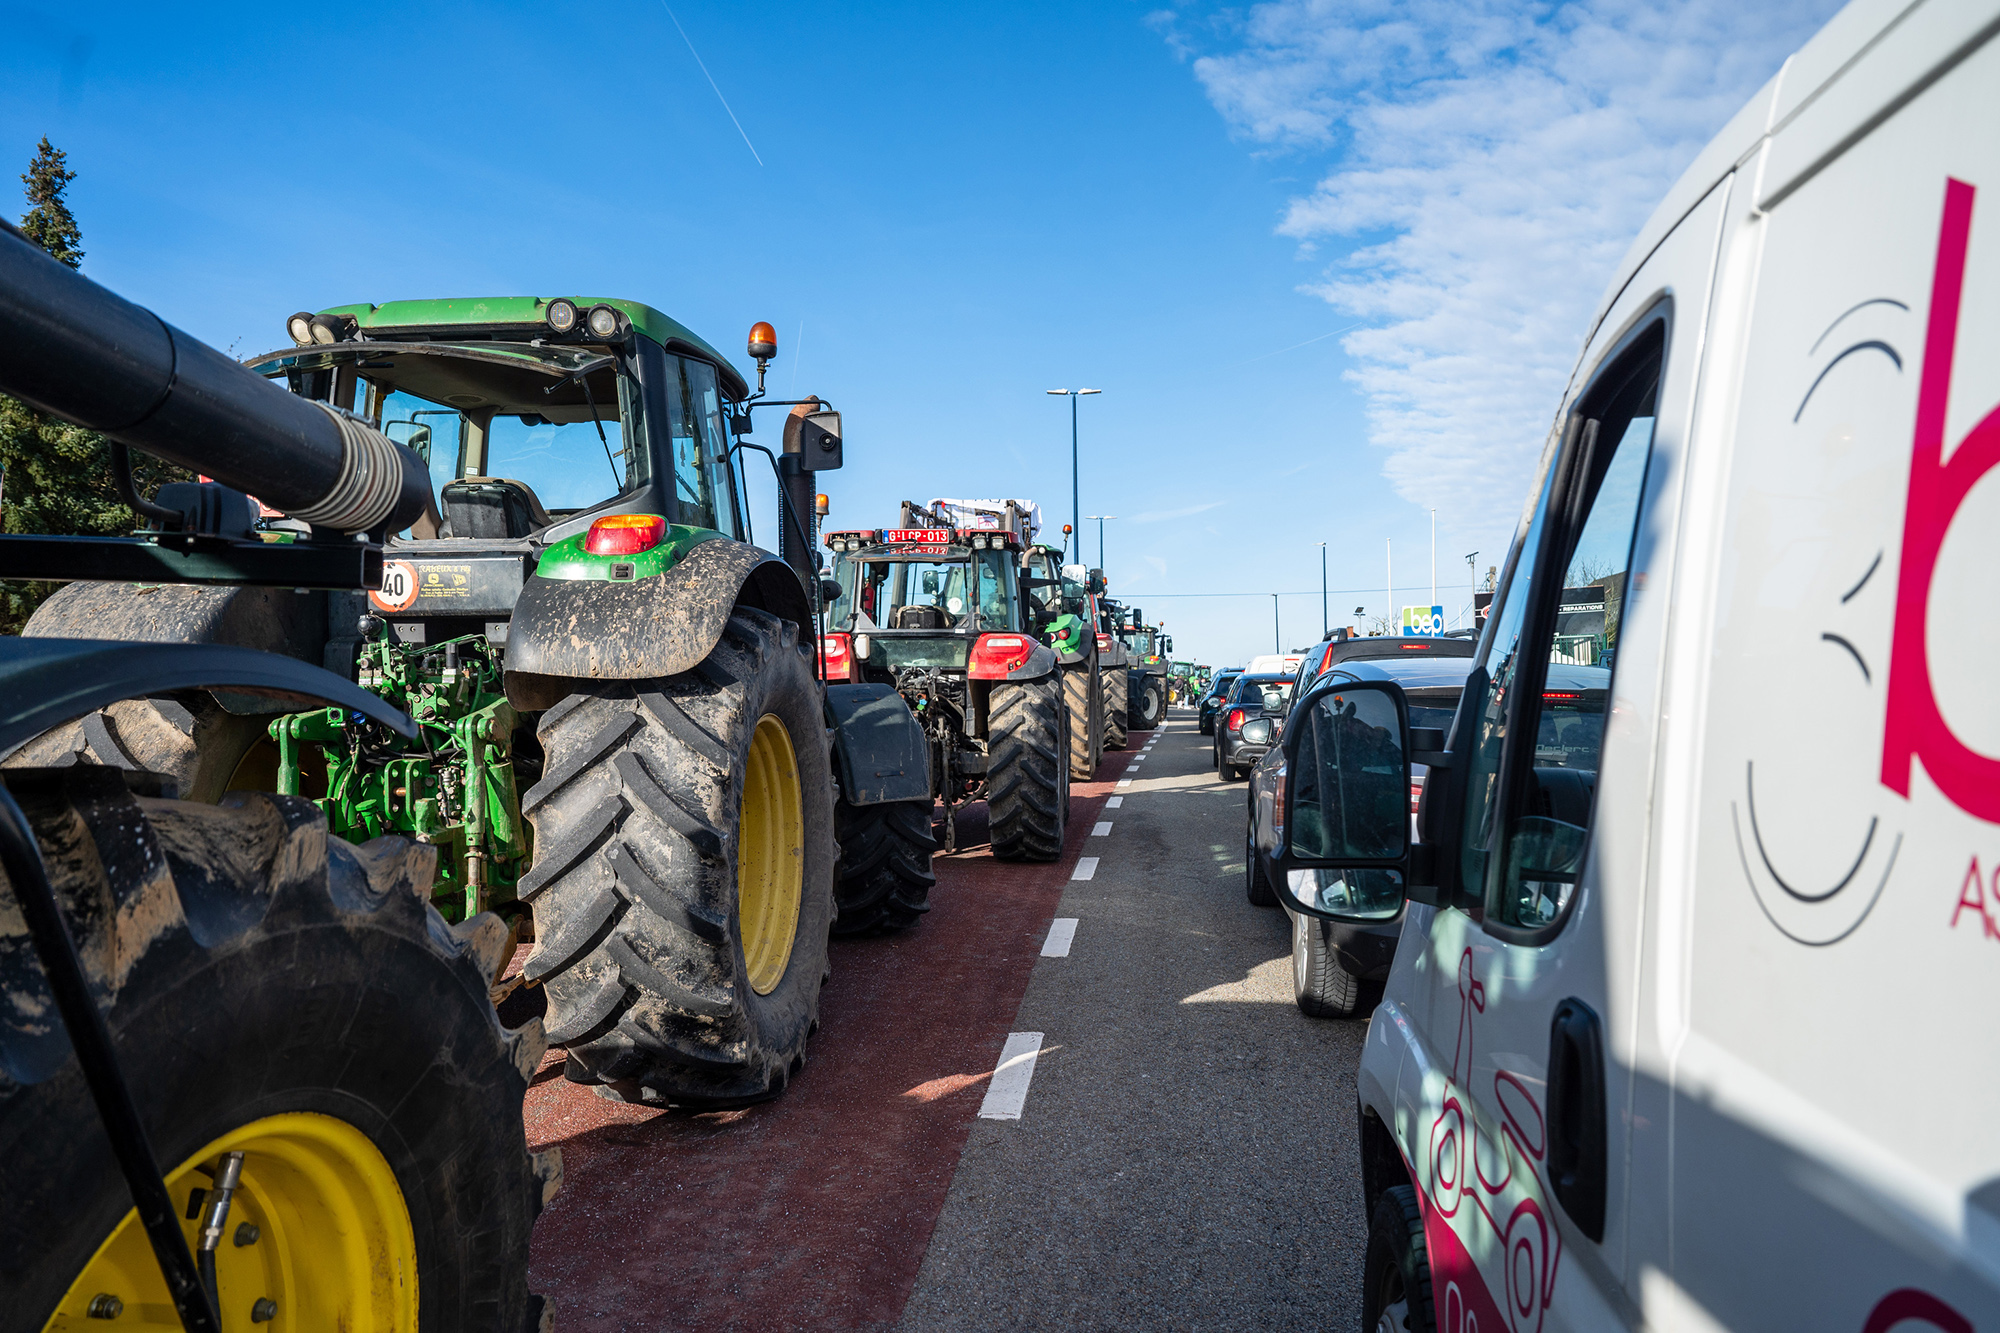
[[0, 136, 190, 634]]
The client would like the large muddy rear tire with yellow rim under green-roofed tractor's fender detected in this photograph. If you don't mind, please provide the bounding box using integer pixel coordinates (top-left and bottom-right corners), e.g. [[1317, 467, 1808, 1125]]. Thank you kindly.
[[520, 608, 836, 1107]]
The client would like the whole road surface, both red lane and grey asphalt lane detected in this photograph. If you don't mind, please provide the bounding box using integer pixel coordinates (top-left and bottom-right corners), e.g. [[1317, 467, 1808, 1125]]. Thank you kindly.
[[522, 711, 1364, 1333]]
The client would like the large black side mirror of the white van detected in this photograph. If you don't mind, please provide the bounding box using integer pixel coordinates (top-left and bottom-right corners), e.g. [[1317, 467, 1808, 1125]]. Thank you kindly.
[[1266, 681, 1412, 923]]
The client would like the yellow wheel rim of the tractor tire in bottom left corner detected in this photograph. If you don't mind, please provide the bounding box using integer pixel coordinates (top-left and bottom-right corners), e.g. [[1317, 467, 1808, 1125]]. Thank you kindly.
[[44, 1111, 416, 1333]]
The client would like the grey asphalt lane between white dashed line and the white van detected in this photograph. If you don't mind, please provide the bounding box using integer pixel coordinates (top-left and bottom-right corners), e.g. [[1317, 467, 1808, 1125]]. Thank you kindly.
[[898, 711, 1366, 1333]]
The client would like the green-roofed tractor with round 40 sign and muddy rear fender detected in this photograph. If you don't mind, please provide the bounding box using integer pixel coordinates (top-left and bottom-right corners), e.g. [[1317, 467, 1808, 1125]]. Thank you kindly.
[[8, 296, 930, 1107]]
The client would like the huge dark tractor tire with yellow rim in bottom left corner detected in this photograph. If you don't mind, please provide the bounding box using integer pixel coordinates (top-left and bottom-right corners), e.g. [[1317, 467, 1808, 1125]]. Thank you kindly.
[[0, 767, 562, 1333]]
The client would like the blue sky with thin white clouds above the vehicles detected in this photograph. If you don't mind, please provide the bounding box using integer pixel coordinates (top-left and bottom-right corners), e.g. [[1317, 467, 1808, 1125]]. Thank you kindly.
[[0, 0, 1834, 664]]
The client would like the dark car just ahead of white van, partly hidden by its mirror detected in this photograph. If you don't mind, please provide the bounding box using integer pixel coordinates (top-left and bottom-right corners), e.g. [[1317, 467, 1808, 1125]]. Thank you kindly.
[[1244, 656, 1610, 1019]]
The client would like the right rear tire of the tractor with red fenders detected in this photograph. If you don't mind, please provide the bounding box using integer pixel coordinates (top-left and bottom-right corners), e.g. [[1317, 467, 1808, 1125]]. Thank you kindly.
[[986, 677, 1070, 861]]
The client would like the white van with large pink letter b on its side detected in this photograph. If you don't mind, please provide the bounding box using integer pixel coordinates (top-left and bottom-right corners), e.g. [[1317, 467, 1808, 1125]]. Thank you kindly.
[[1262, 0, 2000, 1333]]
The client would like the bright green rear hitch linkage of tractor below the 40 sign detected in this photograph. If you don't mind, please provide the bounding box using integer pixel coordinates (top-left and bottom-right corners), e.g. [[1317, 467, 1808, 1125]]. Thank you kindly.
[[270, 634, 532, 923]]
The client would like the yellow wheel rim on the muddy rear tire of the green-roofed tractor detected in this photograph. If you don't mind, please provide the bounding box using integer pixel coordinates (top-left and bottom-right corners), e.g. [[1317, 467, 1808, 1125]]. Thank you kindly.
[[736, 713, 806, 995]]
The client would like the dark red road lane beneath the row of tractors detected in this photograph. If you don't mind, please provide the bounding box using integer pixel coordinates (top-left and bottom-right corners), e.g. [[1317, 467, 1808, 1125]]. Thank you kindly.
[[526, 737, 1140, 1333]]
